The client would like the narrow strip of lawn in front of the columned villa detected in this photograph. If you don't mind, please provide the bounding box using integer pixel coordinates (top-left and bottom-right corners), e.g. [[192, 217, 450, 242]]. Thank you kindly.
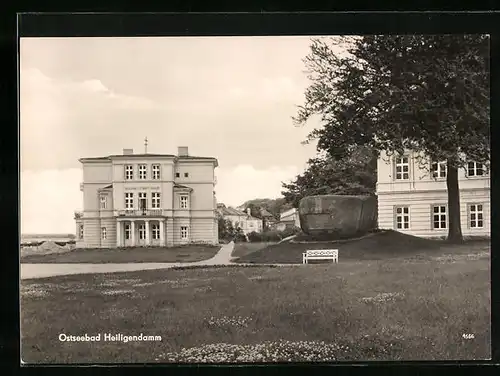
[[21, 245, 220, 264]]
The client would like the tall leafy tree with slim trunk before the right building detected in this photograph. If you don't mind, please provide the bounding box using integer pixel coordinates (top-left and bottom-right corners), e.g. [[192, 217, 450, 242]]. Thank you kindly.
[[294, 34, 490, 242]]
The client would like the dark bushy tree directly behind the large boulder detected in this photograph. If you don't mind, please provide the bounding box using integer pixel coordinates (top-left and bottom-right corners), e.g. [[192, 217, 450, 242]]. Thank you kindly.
[[281, 147, 377, 207]]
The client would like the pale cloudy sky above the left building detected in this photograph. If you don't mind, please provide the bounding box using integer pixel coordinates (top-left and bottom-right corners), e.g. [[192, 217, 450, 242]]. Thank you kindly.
[[19, 36, 319, 233]]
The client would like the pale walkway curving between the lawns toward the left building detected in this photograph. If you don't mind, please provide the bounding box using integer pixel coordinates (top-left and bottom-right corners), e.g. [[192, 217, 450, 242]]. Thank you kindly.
[[20, 242, 238, 279]]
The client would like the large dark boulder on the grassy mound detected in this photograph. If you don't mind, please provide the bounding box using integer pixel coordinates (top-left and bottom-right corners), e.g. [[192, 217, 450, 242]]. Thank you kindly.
[[299, 195, 377, 239]]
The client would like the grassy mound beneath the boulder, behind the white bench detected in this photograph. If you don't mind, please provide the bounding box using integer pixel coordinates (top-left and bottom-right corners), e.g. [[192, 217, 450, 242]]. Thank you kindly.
[[236, 231, 490, 264]]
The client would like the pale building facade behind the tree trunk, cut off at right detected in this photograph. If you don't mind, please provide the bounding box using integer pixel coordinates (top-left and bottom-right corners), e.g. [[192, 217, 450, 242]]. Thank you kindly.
[[376, 152, 491, 238]]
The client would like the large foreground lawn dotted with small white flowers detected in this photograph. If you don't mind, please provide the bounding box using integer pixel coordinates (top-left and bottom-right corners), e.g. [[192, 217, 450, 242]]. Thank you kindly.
[[21, 244, 491, 363]]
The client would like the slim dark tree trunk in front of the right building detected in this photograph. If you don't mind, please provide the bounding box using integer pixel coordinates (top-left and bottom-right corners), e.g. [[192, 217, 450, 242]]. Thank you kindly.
[[446, 160, 464, 244]]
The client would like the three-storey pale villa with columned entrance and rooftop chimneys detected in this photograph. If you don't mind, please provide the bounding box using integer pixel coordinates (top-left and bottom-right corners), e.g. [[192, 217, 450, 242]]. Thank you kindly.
[[75, 147, 218, 248]]
